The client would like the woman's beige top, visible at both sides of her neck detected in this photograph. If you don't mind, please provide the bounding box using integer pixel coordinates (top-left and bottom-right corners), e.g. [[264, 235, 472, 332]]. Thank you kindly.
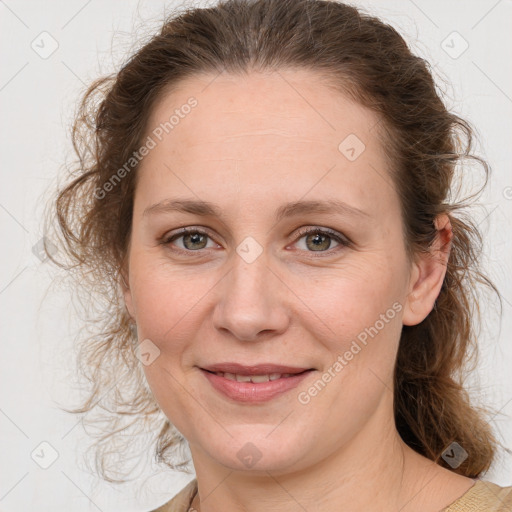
[[152, 479, 512, 512]]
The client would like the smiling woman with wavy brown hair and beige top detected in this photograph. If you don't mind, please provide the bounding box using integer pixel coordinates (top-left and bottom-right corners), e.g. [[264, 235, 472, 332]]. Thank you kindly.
[[45, 0, 512, 512]]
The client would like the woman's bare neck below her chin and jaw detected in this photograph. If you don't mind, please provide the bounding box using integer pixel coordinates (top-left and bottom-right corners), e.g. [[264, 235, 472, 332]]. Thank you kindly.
[[190, 394, 446, 512]]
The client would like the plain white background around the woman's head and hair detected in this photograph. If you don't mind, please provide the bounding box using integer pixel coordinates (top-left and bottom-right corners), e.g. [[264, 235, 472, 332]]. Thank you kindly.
[[0, 0, 512, 512]]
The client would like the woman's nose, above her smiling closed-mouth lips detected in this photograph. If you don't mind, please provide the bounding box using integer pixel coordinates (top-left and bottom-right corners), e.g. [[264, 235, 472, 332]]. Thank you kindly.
[[213, 253, 290, 341]]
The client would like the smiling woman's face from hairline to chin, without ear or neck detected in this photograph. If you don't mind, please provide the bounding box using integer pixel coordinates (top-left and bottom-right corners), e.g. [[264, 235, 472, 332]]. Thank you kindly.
[[125, 71, 428, 472]]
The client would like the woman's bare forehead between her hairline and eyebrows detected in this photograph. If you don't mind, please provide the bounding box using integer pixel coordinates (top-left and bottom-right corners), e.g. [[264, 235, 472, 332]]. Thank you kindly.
[[141, 70, 396, 218]]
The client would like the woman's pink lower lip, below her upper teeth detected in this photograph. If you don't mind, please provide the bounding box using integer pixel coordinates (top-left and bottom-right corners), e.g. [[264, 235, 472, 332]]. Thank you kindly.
[[201, 369, 312, 403]]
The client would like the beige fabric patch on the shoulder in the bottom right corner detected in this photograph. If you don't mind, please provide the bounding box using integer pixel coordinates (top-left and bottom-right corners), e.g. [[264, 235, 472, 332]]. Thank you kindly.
[[442, 480, 512, 512]]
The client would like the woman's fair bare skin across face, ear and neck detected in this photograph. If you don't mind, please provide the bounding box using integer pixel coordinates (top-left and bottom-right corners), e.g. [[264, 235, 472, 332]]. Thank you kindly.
[[124, 70, 474, 512]]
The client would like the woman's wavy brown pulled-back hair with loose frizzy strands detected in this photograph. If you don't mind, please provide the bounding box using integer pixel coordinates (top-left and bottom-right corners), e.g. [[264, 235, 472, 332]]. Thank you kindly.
[[48, 0, 501, 482]]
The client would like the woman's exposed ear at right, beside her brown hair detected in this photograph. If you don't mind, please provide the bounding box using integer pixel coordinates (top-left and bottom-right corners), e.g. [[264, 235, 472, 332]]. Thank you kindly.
[[402, 214, 453, 325]]
